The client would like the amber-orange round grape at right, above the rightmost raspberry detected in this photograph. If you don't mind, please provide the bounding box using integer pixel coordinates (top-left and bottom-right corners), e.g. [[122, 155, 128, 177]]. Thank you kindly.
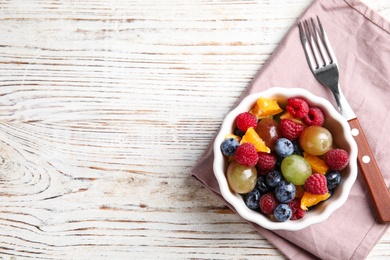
[[299, 126, 333, 155]]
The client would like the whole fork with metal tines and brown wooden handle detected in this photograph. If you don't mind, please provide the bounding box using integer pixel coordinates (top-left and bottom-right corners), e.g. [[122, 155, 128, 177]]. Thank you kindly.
[[298, 16, 390, 223]]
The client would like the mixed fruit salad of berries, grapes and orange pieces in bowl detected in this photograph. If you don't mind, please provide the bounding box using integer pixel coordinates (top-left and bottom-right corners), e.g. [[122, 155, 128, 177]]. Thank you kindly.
[[220, 97, 349, 222]]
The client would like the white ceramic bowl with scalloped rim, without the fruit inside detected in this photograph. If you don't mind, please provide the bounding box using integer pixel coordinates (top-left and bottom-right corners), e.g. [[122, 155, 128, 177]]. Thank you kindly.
[[213, 87, 357, 231]]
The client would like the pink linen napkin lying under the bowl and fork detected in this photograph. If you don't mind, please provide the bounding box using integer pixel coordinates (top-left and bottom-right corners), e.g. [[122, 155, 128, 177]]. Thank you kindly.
[[191, 0, 390, 259]]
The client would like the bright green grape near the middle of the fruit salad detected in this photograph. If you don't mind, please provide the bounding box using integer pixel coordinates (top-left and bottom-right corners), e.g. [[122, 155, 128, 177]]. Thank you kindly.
[[281, 154, 312, 185]]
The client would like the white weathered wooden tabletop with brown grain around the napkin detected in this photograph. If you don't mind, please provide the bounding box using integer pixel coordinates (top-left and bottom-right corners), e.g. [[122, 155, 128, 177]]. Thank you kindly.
[[0, 0, 390, 259]]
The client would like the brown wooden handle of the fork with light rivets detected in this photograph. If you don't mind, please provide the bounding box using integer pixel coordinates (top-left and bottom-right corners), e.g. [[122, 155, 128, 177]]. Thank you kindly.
[[348, 118, 390, 223]]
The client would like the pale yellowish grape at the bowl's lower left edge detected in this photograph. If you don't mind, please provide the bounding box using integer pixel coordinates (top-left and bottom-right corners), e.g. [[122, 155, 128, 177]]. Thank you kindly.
[[226, 161, 257, 194]]
